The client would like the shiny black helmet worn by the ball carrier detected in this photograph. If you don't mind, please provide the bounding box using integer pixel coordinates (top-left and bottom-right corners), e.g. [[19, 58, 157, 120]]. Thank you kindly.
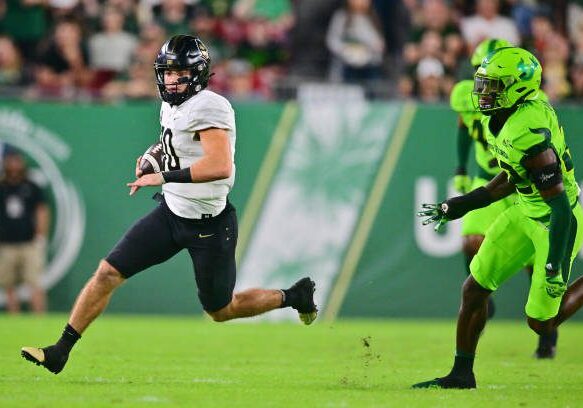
[[154, 35, 211, 105]]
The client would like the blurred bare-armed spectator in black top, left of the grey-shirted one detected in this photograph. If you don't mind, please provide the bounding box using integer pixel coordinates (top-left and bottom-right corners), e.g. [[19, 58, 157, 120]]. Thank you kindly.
[[32, 19, 91, 97]]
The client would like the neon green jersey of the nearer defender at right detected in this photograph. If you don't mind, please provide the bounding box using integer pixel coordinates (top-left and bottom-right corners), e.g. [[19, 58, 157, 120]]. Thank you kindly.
[[482, 98, 579, 218]]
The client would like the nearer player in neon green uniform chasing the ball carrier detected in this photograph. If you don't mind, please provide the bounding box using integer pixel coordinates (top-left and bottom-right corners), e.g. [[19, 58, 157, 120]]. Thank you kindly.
[[414, 47, 583, 388]]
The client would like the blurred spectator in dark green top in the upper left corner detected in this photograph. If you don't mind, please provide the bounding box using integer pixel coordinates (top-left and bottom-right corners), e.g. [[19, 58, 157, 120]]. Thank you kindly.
[[0, 0, 49, 61]]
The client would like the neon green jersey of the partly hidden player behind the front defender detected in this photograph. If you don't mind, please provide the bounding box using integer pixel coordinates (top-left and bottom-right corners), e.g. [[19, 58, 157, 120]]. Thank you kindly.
[[449, 80, 500, 176]]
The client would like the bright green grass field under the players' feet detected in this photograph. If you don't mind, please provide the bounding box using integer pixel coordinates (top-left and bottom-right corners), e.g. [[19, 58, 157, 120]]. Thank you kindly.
[[0, 315, 583, 407]]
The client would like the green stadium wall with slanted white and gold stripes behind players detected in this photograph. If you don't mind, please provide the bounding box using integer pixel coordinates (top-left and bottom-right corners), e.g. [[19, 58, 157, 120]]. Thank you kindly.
[[0, 101, 583, 319]]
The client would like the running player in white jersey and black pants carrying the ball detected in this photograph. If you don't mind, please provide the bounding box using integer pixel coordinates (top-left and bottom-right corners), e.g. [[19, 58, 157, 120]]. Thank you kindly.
[[22, 35, 317, 374]]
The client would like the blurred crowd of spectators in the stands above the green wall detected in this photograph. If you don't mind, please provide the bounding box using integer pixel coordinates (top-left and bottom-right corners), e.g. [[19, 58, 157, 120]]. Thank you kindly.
[[0, 0, 583, 102]]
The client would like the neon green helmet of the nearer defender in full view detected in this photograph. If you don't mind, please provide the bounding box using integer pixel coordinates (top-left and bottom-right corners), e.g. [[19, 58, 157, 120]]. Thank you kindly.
[[472, 47, 542, 114]]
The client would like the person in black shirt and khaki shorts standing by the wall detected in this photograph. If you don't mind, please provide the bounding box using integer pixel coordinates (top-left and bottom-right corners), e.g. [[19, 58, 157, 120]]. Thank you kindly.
[[0, 150, 49, 313]]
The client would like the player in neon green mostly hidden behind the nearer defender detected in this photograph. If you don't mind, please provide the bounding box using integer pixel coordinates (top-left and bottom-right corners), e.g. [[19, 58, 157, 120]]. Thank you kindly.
[[450, 38, 558, 358]]
